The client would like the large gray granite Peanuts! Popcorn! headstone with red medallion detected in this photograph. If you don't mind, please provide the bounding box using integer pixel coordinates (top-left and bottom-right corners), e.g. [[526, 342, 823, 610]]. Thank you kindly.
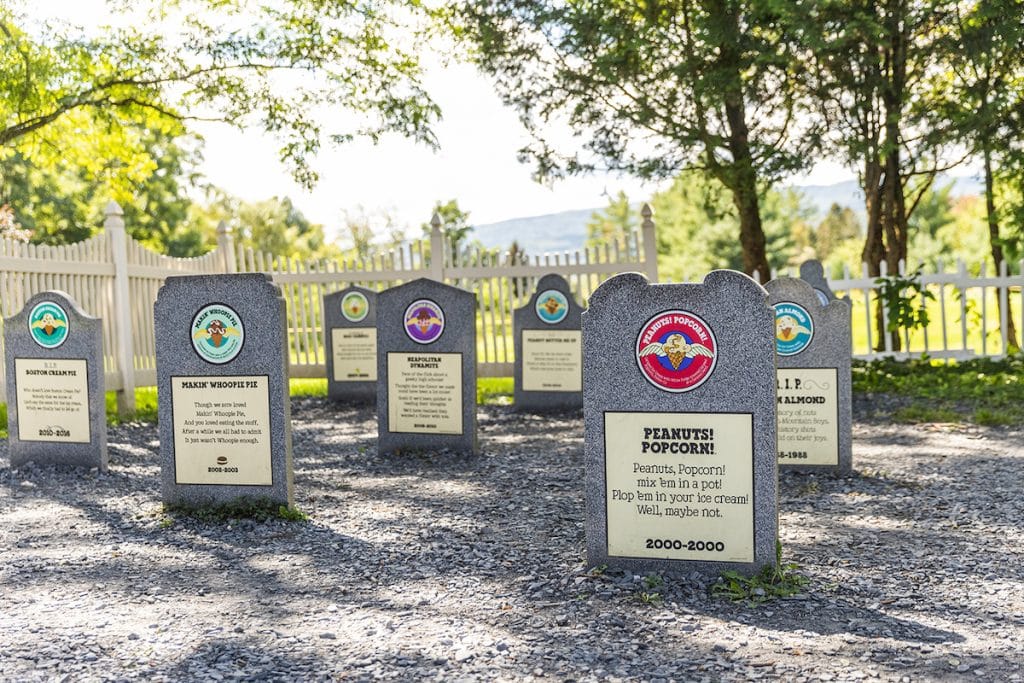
[[583, 270, 778, 574]]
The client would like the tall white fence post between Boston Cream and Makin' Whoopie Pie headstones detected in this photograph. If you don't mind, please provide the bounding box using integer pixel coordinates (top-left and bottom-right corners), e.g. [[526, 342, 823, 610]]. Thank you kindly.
[[103, 201, 135, 417]]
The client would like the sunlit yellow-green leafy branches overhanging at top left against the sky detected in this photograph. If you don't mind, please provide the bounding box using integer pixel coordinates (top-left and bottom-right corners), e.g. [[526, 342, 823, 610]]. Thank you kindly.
[[0, 0, 438, 192]]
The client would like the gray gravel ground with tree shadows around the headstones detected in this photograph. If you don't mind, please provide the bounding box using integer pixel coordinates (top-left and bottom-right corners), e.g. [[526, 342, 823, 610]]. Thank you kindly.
[[0, 397, 1024, 681]]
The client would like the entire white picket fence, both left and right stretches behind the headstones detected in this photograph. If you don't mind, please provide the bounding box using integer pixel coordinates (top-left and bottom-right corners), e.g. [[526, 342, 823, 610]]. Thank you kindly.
[[0, 203, 1024, 412]]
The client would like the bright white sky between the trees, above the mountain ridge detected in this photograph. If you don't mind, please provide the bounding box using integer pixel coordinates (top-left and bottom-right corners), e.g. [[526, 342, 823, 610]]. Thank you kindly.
[[23, 0, 853, 241]]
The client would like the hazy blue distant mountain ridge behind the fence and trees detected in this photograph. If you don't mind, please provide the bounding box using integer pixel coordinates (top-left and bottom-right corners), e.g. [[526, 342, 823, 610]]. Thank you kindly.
[[472, 176, 982, 255]]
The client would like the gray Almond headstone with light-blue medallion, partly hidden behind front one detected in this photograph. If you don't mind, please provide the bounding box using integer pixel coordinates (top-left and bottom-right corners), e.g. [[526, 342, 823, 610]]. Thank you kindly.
[[765, 278, 853, 474]]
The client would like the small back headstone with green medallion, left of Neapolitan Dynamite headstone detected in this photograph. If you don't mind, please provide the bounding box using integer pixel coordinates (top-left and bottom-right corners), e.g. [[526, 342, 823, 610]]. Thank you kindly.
[[324, 286, 377, 403]]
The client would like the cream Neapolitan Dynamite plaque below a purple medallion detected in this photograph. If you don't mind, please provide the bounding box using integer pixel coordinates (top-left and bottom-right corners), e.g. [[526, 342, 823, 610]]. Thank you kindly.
[[387, 353, 462, 434]]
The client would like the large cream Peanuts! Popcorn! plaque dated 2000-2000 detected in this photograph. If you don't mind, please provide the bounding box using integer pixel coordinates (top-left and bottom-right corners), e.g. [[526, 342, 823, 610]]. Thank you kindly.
[[604, 413, 754, 562]]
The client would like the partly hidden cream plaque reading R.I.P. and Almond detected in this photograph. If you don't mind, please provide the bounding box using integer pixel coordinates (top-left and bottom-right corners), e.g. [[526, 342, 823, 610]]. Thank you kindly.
[[778, 368, 839, 465]]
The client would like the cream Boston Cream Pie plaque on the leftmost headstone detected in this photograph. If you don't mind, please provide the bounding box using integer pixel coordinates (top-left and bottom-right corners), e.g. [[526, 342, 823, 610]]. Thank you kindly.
[[14, 358, 91, 443]]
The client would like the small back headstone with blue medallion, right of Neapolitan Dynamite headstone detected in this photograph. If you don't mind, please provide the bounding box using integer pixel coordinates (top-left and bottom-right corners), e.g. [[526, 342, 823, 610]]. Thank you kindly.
[[512, 274, 583, 411]]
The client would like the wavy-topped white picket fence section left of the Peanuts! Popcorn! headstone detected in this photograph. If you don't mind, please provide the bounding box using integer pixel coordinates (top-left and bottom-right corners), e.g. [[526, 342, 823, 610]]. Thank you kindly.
[[0, 203, 657, 413]]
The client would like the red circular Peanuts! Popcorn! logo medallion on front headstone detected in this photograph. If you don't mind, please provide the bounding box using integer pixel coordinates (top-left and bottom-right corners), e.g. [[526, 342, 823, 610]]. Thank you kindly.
[[636, 310, 718, 393]]
